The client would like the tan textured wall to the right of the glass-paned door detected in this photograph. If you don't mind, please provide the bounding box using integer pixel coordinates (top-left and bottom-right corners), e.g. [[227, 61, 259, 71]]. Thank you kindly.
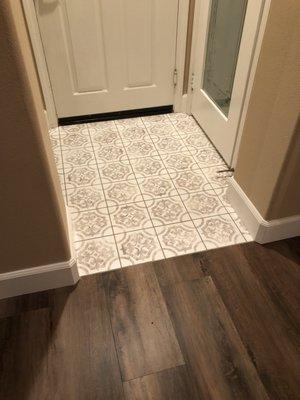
[[235, 0, 300, 219]]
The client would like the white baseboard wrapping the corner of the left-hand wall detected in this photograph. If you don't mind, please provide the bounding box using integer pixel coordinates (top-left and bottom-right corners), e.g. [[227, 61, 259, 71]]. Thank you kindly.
[[0, 208, 79, 299]]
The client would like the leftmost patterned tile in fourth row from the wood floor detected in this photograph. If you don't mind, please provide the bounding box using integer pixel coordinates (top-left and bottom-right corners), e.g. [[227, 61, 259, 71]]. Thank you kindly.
[[65, 166, 100, 189]]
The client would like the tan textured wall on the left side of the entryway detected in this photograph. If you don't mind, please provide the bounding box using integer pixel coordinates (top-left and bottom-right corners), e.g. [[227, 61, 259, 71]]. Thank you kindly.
[[0, 0, 70, 273]]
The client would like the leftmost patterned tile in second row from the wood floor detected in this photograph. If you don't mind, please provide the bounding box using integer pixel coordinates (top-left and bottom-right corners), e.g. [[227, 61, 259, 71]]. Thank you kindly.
[[72, 208, 113, 241]]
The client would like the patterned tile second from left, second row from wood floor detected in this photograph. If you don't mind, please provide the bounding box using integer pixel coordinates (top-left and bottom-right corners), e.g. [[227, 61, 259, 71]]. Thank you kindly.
[[109, 202, 153, 234]]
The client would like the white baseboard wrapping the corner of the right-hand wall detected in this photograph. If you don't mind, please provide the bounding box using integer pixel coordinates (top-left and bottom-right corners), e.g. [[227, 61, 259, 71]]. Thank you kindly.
[[227, 178, 300, 243]]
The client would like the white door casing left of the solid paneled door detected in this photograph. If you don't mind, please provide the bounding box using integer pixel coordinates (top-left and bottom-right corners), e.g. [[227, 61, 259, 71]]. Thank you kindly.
[[22, 0, 58, 128]]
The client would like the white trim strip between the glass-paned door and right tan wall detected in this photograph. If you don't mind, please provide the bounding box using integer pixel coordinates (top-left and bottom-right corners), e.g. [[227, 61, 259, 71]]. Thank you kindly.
[[231, 0, 271, 168]]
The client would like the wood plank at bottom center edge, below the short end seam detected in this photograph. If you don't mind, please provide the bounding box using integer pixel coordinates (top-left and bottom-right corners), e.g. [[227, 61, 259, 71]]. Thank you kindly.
[[124, 365, 200, 400]]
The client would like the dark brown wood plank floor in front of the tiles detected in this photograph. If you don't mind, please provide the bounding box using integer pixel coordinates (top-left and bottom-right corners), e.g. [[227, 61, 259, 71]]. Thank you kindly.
[[0, 238, 300, 400]]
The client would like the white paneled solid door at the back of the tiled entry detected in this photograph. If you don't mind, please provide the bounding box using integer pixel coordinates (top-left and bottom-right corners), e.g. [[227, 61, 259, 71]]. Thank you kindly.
[[34, 0, 178, 117]]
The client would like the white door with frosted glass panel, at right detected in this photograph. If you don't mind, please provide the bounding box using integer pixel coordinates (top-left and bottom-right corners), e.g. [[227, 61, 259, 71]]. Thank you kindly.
[[191, 0, 264, 166]]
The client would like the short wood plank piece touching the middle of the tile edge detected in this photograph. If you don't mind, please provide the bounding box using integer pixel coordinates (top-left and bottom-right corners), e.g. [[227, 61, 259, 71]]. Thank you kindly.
[[153, 254, 204, 286]]
